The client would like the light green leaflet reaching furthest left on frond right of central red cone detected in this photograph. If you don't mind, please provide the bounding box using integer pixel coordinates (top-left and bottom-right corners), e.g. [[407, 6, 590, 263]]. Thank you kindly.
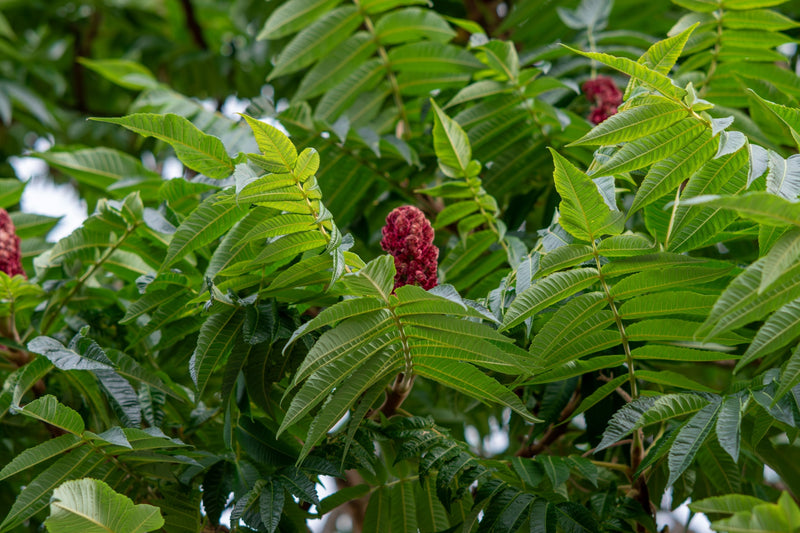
[[501, 268, 597, 331]]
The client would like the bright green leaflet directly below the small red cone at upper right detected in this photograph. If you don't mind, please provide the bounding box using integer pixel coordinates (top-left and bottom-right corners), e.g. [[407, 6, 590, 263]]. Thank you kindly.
[[569, 95, 688, 146]]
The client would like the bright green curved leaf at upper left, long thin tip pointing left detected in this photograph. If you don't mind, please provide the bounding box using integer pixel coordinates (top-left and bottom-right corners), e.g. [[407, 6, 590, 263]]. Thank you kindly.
[[91, 113, 235, 179]]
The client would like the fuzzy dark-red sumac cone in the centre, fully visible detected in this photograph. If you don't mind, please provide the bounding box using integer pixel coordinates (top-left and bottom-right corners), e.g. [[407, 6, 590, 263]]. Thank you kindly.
[[381, 205, 439, 290]]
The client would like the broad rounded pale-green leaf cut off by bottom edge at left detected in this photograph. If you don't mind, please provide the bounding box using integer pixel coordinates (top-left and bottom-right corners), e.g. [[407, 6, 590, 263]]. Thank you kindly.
[[45, 478, 164, 533]]
